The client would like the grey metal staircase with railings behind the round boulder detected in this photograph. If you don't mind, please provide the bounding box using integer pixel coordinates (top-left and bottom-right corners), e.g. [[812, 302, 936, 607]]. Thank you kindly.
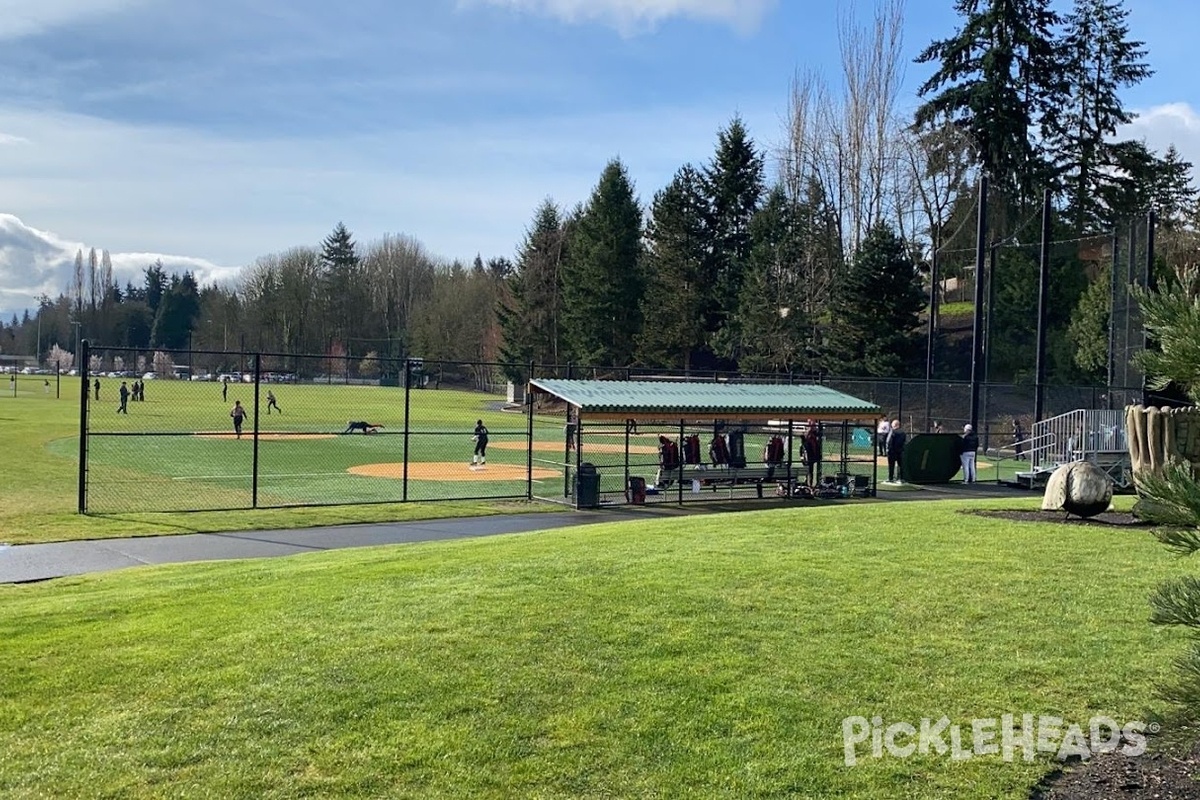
[[1016, 408, 1133, 489]]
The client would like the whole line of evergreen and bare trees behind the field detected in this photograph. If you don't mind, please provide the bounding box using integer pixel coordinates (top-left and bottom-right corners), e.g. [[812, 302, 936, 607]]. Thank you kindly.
[[0, 0, 1196, 381]]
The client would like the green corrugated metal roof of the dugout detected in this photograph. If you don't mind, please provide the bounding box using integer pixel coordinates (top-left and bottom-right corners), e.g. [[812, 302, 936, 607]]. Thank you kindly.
[[529, 379, 880, 417]]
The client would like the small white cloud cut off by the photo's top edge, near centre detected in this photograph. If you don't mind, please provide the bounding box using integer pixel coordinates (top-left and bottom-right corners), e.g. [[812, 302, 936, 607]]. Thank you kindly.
[[466, 0, 775, 35]]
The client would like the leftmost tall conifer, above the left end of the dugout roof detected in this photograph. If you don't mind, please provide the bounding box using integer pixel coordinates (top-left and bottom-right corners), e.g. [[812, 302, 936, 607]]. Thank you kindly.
[[496, 198, 566, 380]]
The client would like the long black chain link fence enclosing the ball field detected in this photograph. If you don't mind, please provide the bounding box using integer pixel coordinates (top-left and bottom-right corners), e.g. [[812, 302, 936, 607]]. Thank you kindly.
[[75, 348, 1141, 512]]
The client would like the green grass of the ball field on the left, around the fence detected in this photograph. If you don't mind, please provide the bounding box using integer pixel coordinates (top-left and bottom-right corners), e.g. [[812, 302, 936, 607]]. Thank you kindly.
[[0, 375, 546, 543]]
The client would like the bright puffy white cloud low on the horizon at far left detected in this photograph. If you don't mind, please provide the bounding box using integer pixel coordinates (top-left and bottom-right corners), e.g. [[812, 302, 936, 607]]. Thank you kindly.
[[0, 213, 236, 319]]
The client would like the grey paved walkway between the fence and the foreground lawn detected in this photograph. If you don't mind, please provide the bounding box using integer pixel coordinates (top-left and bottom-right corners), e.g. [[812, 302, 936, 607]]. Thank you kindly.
[[0, 483, 1032, 583]]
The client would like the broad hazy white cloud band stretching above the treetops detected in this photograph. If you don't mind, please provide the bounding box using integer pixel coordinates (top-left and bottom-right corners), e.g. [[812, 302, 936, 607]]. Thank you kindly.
[[0, 100, 779, 294]]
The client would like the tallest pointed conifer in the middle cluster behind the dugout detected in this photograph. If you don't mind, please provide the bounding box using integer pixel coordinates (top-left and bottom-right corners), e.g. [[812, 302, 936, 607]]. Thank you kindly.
[[702, 118, 763, 350]]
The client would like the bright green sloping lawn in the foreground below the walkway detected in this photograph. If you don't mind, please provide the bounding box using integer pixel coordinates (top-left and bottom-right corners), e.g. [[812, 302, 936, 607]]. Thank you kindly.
[[0, 503, 1186, 799]]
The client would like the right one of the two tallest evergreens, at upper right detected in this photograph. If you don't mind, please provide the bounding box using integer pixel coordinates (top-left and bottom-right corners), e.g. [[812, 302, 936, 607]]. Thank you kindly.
[[1050, 0, 1153, 234]]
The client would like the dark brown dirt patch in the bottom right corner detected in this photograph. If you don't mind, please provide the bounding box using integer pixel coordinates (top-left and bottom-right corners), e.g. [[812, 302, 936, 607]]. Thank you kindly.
[[1030, 748, 1200, 800]]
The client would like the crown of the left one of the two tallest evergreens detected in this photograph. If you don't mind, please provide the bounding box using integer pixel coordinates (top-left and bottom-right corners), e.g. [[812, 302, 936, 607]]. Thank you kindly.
[[917, 0, 1066, 204]]
